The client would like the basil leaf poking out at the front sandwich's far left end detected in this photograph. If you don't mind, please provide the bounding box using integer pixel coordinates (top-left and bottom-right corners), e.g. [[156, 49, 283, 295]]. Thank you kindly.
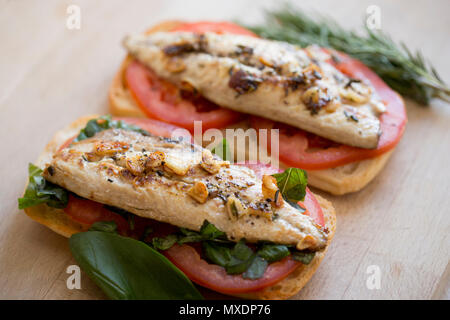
[[18, 163, 69, 209]]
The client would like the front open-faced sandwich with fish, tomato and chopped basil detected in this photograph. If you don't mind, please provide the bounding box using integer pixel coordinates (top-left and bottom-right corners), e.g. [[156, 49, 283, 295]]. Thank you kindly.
[[19, 116, 336, 299]]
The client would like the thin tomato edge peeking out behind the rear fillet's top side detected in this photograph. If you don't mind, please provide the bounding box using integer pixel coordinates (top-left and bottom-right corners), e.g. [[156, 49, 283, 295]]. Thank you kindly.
[[171, 21, 257, 37]]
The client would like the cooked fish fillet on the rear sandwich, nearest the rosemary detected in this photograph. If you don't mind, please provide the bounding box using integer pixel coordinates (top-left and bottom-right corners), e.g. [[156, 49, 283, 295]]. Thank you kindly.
[[123, 32, 385, 149]]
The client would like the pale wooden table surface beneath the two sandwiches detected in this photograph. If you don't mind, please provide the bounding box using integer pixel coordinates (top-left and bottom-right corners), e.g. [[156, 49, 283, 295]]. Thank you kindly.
[[0, 0, 450, 299]]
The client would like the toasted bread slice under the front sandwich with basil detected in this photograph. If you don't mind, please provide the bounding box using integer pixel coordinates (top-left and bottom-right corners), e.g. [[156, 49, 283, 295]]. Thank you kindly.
[[24, 115, 336, 300]]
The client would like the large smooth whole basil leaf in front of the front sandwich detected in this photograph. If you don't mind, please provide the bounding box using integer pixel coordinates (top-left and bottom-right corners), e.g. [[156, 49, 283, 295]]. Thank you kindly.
[[69, 231, 203, 300]]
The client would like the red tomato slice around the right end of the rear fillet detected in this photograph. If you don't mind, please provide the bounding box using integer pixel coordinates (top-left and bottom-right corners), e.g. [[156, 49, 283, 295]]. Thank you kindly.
[[250, 53, 407, 170]]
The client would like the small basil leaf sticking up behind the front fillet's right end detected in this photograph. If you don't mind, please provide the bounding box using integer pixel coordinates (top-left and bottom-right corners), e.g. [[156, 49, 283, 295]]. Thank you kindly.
[[272, 168, 308, 211]]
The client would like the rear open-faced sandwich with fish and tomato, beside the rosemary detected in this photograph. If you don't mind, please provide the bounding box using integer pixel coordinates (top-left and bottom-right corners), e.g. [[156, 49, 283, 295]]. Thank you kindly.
[[109, 21, 406, 194]]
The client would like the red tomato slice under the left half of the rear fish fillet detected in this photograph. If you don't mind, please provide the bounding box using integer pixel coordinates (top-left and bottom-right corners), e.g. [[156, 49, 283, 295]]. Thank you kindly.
[[125, 61, 241, 132]]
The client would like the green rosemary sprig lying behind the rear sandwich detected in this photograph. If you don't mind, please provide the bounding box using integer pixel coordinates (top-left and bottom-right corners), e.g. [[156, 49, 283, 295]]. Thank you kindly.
[[246, 5, 450, 105]]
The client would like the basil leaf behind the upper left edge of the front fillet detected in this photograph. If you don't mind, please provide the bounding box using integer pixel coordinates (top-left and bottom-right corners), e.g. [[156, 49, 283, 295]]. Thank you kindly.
[[73, 115, 150, 142]]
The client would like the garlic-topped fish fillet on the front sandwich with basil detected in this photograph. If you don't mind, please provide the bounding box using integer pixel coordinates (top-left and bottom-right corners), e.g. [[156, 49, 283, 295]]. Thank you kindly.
[[43, 129, 327, 250]]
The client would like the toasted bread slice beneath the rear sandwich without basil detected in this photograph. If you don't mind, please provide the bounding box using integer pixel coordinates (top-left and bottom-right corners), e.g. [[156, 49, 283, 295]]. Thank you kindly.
[[109, 21, 393, 195]]
